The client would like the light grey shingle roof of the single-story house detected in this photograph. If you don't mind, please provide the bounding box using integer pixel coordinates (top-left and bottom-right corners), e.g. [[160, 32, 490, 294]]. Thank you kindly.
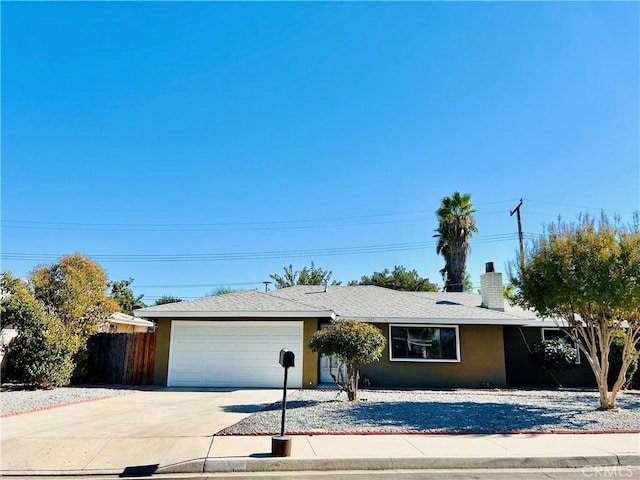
[[134, 285, 556, 325]]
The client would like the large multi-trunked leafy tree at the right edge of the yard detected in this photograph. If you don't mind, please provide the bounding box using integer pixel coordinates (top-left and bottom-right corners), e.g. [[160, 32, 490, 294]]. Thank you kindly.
[[511, 214, 640, 409]]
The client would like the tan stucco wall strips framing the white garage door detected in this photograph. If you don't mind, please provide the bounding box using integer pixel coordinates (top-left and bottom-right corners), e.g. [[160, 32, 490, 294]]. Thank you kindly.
[[153, 318, 318, 388]]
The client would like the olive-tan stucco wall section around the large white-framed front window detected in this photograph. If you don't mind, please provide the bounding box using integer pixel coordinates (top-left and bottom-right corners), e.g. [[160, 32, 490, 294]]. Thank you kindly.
[[360, 324, 506, 388]]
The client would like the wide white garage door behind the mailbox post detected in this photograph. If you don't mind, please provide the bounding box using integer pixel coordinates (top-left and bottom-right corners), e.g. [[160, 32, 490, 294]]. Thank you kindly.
[[167, 321, 303, 388]]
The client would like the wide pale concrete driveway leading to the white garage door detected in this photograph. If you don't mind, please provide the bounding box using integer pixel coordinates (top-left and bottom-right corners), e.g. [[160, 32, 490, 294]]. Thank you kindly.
[[0, 388, 282, 473]]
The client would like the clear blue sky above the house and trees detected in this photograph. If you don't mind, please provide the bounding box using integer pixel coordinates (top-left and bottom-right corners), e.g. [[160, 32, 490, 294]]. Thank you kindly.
[[1, 2, 640, 303]]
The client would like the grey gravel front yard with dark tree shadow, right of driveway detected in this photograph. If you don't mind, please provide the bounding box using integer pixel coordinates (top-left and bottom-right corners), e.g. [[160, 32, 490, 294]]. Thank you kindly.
[[219, 390, 640, 435]]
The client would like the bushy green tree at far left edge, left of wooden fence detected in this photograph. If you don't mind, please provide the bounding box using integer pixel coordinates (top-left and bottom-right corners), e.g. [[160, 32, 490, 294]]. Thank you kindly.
[[0, 273, 86, 388]]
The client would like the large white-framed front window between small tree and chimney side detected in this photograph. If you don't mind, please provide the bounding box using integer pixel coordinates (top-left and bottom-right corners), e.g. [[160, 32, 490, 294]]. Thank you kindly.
[[390, 325, 460, 362]]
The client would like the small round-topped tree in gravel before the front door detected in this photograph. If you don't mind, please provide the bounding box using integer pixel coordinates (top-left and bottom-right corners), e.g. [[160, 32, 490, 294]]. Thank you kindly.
[[310, 319, 387, 401]]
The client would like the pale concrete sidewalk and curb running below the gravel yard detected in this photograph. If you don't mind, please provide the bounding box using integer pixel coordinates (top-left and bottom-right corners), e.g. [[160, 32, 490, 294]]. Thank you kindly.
[[190, 434, 640, 473]]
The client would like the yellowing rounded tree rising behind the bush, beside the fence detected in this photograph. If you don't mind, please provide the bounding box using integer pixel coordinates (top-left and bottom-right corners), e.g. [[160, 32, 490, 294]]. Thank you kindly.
[[30, 253, 119, 335]]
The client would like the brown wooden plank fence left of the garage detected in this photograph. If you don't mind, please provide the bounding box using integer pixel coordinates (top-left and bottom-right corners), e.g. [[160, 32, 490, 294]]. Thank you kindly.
[[87, 333, 157, 385]]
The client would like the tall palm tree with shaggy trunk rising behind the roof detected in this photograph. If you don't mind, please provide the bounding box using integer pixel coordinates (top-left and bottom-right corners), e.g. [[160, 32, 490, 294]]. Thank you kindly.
[[434, 191, 478, 292]]
